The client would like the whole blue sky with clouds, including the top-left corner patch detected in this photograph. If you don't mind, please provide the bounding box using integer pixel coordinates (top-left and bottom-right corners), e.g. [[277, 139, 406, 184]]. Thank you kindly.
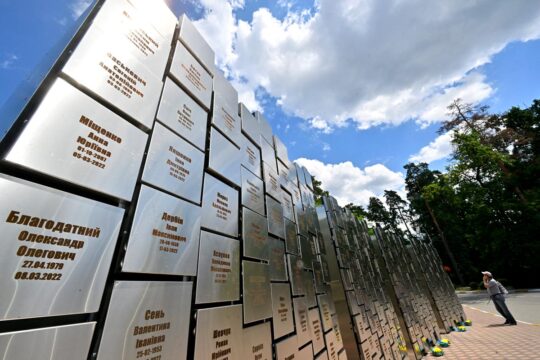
[[0, 0, 540, 205]]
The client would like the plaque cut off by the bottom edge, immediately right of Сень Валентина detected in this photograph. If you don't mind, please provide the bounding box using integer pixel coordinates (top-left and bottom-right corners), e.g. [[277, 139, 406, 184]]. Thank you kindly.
[[192, 305, 243, 360]]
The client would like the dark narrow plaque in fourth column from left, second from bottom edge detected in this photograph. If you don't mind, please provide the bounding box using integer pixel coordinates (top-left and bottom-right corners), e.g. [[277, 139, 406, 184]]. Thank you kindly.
[[242, 261, 272, 324]]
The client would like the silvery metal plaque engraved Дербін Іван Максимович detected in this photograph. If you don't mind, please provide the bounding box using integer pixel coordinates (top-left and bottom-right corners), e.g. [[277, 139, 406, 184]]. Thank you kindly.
[[122, 185, 201, 276]]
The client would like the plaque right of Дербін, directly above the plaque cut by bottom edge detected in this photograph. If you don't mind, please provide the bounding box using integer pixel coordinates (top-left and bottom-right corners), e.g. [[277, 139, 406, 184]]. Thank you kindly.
[[195, 231, 240, 304]]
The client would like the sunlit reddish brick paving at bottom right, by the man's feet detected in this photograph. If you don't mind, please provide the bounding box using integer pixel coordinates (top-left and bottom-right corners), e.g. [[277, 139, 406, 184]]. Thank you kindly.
[[427, 305, 540, 360]]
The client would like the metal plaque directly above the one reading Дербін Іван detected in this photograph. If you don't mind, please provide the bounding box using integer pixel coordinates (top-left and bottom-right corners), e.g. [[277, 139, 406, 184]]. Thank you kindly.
[[142, 123, 204, 204]]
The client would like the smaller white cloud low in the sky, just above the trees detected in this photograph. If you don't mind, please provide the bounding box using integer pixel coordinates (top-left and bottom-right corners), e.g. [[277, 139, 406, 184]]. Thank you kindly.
[[295, 158, 405, 206]]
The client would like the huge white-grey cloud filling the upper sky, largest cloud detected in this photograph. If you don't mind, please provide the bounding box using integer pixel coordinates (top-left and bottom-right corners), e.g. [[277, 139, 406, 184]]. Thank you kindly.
[[193, 0, 540, 133]]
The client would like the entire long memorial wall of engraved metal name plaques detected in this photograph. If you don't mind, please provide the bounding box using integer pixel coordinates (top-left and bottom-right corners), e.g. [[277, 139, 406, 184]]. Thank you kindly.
[[0, 0, 463, 360]]
